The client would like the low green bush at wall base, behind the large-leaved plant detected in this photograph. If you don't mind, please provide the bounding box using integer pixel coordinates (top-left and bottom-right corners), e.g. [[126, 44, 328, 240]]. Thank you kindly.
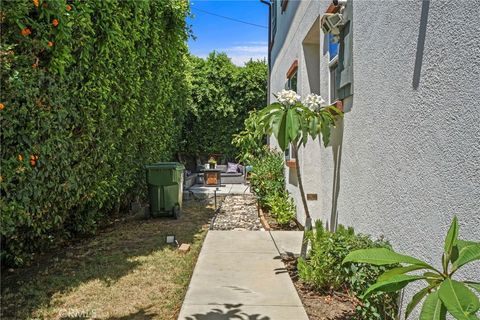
[[298, 221, 398, 320]]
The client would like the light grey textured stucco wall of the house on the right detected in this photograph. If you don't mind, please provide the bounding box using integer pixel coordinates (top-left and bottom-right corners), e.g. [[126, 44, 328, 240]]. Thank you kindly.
[[271, 0, 480, 316]]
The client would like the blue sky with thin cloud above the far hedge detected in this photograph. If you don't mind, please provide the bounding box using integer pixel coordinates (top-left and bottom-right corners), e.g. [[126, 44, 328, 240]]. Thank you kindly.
[[188, 0, 268, 65]]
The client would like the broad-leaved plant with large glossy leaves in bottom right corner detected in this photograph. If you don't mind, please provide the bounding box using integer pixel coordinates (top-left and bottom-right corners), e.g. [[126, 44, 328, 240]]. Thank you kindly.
[[344, 217, 480, 320]]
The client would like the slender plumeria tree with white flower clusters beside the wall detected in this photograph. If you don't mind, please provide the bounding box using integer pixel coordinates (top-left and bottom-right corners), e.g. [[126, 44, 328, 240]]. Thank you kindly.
[[258, 90, 343, 258]]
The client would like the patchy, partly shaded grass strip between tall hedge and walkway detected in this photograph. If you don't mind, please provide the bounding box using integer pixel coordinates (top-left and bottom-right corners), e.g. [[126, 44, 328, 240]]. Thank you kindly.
[[1, 204, 213, 320]]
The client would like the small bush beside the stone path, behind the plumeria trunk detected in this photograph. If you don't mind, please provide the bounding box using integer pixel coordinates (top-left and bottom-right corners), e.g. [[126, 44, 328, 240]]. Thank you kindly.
[[250, 147, 285, 205]]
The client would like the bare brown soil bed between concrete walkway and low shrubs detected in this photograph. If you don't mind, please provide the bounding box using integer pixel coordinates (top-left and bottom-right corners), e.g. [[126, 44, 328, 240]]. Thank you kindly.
[[282, 256, 355, 320]]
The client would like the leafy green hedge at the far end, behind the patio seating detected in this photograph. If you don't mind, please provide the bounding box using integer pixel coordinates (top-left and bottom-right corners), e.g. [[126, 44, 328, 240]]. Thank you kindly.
[[182, 52, 267, 160]]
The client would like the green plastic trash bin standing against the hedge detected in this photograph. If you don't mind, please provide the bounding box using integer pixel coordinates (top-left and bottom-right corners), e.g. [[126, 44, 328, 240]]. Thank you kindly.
[[145, 162, 185, 219]]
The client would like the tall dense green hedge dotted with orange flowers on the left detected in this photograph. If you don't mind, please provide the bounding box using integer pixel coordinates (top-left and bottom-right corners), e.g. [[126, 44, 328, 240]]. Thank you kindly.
[[0, 0, 190, 265]]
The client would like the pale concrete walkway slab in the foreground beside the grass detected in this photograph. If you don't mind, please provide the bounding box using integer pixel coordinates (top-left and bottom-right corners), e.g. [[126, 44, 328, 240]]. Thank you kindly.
[[179, 231, 308, 320]]
